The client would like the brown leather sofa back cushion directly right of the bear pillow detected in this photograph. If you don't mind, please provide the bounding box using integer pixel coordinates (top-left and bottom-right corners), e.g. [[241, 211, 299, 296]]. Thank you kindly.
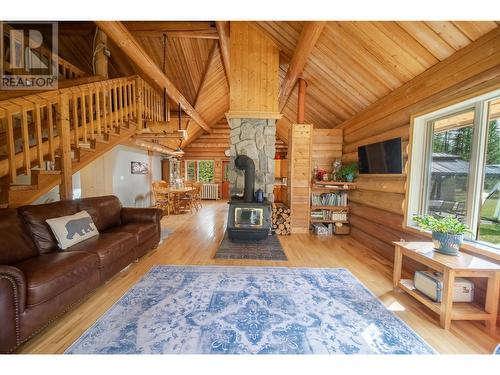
[[76, 195, 122, 232]]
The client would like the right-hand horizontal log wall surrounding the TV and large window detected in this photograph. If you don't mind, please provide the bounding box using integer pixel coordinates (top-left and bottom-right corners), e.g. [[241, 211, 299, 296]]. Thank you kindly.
[[340, 28, 500, 324]]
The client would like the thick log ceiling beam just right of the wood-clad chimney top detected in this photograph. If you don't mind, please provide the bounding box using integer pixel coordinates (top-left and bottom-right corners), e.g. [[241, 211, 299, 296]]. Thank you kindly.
[[279, 21, 326, 112]]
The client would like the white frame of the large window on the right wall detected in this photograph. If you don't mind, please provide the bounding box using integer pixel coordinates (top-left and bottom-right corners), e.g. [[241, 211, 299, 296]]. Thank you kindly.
[[404, 90, 500, 255]]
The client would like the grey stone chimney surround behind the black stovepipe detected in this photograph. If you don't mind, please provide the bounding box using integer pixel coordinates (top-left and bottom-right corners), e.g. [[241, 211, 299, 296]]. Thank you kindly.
[[229, 118, 276, 202]]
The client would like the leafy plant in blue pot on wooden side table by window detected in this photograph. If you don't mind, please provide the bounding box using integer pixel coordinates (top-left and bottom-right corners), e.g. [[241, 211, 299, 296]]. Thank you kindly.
[[413, 215, 470, 255]]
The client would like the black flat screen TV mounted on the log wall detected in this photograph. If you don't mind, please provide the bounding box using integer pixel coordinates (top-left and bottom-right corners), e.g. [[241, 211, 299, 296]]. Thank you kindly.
[[358, 138, 403, 174]]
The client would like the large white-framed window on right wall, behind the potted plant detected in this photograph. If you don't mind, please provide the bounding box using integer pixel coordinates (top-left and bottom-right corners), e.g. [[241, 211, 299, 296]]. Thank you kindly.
[[406, 91, 500, 248]]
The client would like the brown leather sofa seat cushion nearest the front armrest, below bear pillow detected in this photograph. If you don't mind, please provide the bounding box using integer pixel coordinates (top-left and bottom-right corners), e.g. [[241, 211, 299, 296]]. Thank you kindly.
[[15, 251, 99, 306]]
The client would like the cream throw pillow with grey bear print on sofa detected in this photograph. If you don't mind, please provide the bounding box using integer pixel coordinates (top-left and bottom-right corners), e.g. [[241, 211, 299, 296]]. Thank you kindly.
[[46, 211, 99, 250]]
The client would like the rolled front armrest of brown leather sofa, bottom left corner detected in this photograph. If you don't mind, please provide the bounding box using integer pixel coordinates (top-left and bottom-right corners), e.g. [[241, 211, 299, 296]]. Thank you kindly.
[[0, 265, 26, 353]]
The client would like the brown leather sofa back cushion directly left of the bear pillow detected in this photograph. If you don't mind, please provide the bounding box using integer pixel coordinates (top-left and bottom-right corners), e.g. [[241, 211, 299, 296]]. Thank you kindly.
[[18, 200, 79, 254]]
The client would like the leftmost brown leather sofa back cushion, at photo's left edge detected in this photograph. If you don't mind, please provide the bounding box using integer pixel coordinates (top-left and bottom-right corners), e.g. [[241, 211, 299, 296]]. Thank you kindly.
[[0, 208, 38, 265]]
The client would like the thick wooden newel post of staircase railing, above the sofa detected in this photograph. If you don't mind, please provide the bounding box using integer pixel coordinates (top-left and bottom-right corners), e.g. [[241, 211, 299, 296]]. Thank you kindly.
[[57, 94, 73, 200]]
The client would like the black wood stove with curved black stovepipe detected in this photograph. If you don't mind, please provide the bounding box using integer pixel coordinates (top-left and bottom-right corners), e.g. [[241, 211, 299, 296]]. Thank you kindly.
[[227, 155, 271, 241]]
